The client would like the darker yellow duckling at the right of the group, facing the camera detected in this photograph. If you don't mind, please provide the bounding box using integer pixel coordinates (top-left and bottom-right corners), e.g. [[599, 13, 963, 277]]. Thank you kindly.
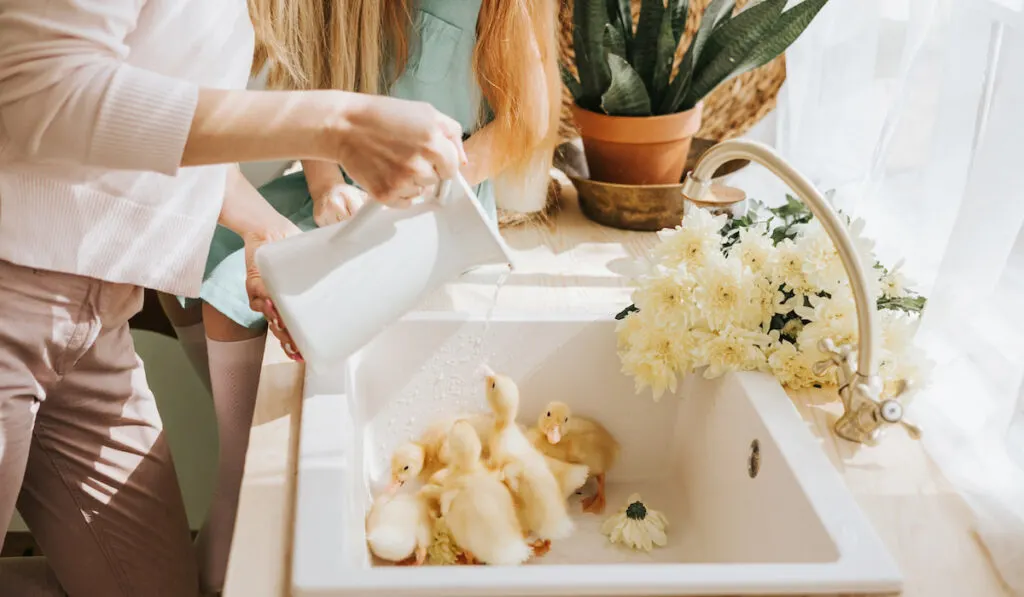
[[527, 402, 620, 513]]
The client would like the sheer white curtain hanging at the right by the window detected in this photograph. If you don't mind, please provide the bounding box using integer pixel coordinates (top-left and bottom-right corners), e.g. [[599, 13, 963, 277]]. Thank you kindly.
[[748, 0, 1024, 595]]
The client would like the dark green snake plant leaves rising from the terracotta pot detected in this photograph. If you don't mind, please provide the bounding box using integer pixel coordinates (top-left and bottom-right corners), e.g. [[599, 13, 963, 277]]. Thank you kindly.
[[562, 0, 827, 117]]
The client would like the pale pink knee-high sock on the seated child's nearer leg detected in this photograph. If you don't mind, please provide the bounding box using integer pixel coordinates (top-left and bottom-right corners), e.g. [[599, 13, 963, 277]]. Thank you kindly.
[[197, 336, 266, 592]]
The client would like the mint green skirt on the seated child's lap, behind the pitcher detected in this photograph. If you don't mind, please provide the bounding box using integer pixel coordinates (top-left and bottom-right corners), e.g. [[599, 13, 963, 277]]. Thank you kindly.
[[178, 172, 498, 329]]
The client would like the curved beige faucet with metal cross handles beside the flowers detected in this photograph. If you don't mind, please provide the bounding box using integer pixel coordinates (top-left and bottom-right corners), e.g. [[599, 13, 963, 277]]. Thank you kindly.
[[682, 139, 921, 445]]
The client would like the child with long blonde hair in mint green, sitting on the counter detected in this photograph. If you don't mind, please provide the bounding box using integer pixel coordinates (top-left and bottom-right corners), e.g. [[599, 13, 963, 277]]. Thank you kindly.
[[163, 0, 561, 590]]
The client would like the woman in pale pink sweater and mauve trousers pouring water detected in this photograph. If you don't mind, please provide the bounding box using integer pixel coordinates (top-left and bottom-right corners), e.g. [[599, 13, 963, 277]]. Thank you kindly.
[[0, 0, 465, 597]]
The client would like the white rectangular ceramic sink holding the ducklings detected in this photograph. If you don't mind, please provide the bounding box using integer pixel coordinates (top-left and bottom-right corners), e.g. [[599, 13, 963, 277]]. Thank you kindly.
[[293, 314, 902, 597]]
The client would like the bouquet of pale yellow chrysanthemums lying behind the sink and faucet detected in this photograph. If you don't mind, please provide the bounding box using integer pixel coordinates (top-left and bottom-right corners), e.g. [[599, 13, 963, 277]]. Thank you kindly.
[[616, 197, 929, 400]]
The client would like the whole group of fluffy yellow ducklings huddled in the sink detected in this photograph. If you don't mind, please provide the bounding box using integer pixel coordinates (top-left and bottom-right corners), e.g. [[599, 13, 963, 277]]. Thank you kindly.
[[367, 372, 618, 565]]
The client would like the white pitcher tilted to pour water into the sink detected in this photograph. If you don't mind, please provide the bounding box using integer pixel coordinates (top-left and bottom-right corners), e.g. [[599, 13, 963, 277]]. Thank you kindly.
[[256, 175, 512, 369]]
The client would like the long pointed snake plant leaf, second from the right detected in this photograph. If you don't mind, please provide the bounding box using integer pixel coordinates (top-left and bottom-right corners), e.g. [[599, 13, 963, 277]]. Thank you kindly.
[[682, 0, 786, 110]]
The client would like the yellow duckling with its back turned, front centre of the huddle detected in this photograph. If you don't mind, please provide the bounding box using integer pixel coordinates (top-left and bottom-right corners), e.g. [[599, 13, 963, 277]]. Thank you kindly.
[[423, 421, 532, 565]]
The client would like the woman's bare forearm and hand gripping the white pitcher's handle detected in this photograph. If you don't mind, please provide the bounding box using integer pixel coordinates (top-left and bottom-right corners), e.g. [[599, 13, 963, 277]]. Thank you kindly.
[[181, 89, 467, 204]]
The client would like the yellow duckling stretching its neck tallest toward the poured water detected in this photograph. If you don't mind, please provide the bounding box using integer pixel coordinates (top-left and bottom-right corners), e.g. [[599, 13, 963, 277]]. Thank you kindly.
[[486, 375, 573, 553]]
